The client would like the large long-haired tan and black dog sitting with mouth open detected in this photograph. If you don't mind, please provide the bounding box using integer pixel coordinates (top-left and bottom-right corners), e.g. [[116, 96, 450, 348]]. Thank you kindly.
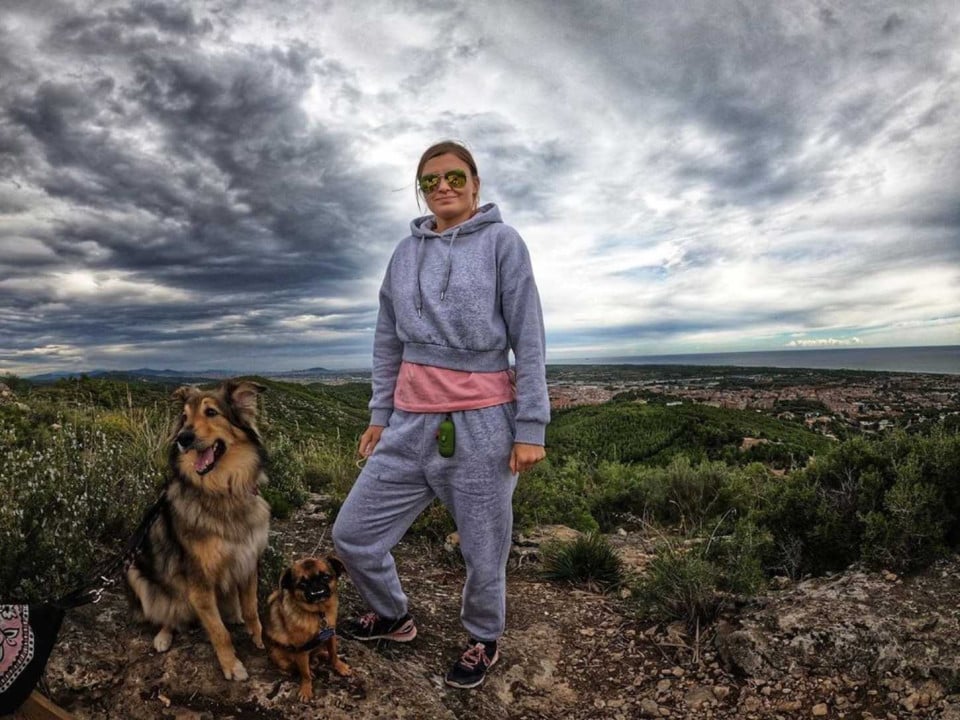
[[127, 381, 270, 680]]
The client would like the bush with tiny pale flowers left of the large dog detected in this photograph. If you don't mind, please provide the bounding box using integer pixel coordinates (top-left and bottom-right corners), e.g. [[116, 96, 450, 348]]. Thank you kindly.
[[0, 410, 163, 601]]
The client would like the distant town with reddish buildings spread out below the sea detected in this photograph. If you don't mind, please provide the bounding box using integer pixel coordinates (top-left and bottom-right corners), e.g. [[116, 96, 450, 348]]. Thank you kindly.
[[548, 365, 960, 438]]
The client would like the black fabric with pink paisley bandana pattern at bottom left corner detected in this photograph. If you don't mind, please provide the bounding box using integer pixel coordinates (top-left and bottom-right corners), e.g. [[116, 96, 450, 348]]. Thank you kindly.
[[0, 604, 64, 715]]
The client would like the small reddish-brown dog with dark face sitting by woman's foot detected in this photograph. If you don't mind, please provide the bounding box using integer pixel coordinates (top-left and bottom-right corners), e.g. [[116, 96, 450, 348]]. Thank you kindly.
[[264, 555, 352, 702]]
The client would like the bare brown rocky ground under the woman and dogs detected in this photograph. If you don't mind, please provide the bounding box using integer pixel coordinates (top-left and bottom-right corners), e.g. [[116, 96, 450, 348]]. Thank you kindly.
[[37, 496, 960, 720]]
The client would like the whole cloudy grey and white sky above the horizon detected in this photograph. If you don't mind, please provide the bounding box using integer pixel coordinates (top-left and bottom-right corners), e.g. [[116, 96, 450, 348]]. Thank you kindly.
[[0, 0, 960, 375]]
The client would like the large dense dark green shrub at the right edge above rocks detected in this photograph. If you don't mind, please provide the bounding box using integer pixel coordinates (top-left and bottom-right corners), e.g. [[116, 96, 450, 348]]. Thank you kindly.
[[753, 428, 960, 576]]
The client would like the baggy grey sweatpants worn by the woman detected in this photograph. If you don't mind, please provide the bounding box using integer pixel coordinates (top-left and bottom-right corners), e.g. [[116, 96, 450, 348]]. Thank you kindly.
[[333, 403, 517, 641]]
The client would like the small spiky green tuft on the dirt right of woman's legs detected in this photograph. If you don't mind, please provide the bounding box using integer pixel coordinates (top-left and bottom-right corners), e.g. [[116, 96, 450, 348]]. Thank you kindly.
[[541, 533, 623, 590]]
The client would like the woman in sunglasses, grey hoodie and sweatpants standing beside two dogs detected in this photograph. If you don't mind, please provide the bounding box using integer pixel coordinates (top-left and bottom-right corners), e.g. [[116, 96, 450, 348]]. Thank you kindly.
[[333, 142, 550, 688]]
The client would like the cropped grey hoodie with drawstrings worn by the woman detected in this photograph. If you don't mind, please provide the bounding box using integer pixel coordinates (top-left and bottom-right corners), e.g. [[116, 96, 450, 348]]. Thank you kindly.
[[370, 203, 550, 445]]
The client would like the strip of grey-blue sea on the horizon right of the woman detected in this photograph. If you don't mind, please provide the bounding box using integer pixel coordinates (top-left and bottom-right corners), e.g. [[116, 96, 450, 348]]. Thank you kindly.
[[558, 345, 960, 375]]
